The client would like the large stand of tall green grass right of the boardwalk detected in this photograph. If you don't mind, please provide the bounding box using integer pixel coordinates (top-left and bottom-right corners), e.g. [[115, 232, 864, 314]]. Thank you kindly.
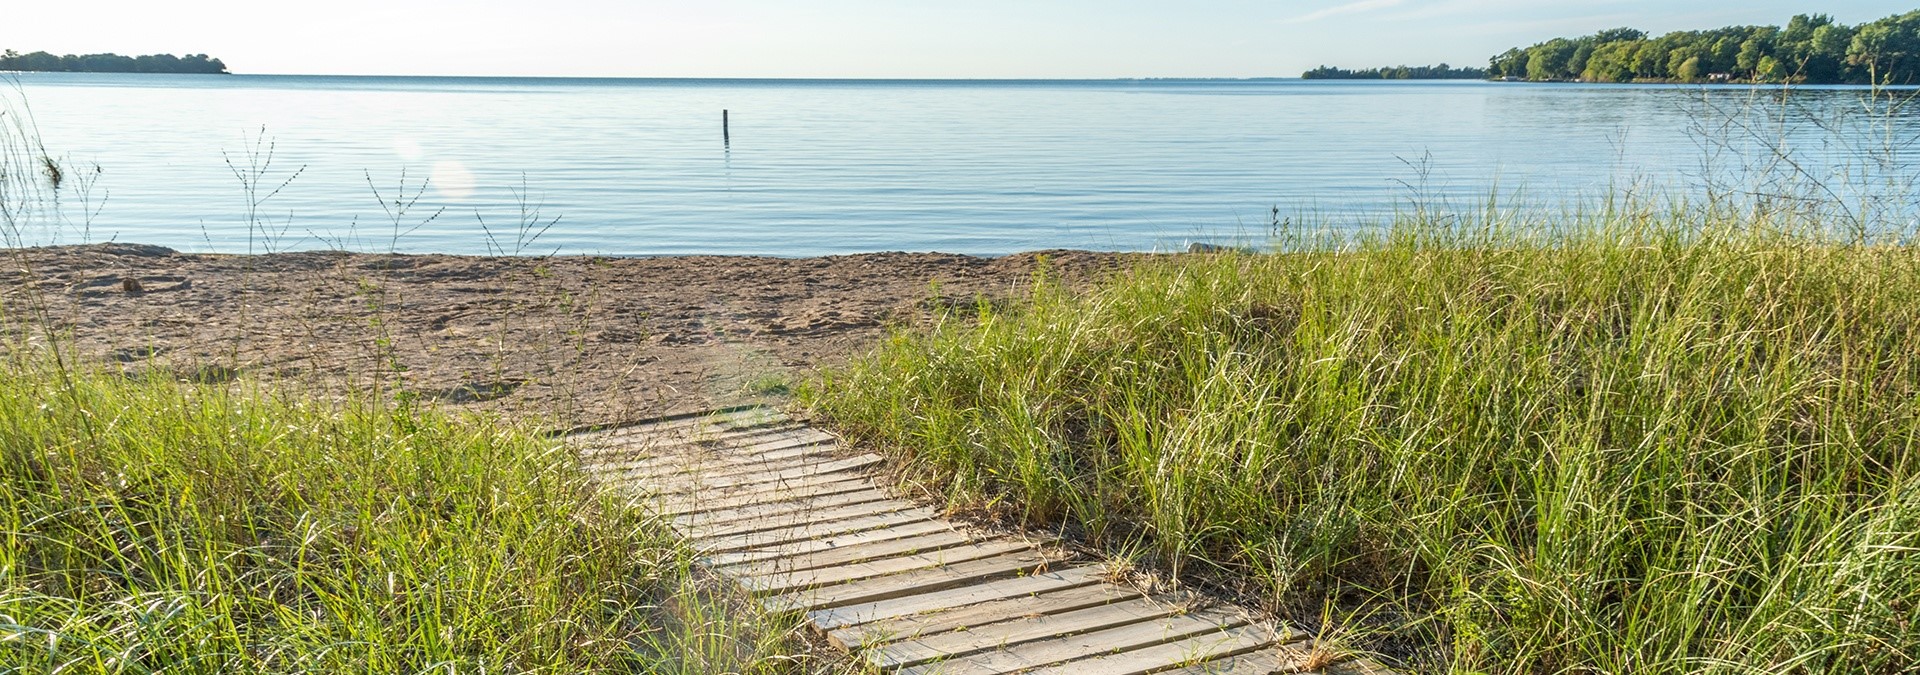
[[804, 203, 1920, 673]]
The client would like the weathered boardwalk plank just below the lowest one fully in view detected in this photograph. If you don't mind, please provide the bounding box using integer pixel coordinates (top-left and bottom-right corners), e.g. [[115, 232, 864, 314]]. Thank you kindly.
[[899, 612, 1246, 675]]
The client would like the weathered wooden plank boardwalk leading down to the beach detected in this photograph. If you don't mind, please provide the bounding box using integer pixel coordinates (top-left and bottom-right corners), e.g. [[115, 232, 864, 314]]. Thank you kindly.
[[572, 408, 1377, 675]]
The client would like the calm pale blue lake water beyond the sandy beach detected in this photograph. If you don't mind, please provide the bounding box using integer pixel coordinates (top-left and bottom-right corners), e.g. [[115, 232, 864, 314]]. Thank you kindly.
[[10, 73, 1914, 255]]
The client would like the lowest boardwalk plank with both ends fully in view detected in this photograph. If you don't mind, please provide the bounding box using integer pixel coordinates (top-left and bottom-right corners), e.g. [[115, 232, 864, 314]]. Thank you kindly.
[[860, 596, 1183, 669]]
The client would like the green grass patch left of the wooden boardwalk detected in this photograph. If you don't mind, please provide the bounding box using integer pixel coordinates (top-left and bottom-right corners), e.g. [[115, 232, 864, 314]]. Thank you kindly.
[[0, 347, 791, 673]]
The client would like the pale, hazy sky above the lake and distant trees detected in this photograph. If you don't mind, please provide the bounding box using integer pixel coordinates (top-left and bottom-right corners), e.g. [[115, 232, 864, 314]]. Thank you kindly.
[[0, 0, 1916, 79]]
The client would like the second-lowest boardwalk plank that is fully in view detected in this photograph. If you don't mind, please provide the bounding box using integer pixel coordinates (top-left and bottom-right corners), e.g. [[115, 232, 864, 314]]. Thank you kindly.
[[828, 583, 1144, 650]]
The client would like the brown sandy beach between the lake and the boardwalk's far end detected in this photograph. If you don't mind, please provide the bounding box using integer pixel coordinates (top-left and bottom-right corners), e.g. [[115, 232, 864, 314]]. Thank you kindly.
[[0, 244, 1137, 426]]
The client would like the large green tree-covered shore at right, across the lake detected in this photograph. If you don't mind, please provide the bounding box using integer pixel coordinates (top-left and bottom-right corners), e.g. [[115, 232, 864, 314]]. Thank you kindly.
[[1488, 10, 1920, 84]]
